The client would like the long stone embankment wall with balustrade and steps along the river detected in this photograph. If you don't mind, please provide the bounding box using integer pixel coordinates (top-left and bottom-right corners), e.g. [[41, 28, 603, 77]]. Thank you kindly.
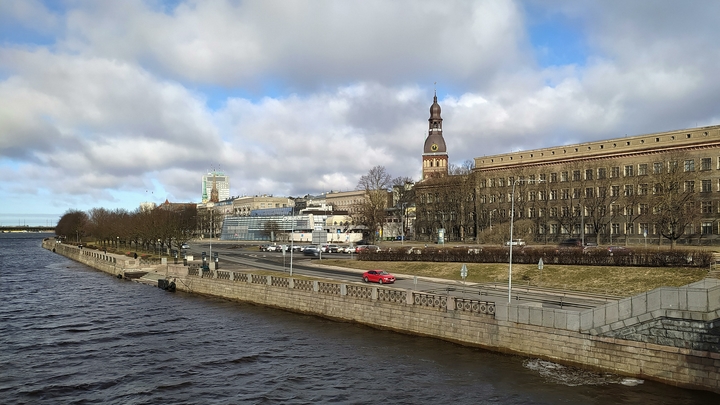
[[45, 238, 720, 393]]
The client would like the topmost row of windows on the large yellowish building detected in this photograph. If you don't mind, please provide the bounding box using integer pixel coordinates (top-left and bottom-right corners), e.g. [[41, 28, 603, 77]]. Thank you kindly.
[[480, 156, 720, 187]]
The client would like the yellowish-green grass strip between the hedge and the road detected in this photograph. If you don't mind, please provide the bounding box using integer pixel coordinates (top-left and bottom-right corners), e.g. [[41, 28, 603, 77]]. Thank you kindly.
[[322, 259, 708, 297]]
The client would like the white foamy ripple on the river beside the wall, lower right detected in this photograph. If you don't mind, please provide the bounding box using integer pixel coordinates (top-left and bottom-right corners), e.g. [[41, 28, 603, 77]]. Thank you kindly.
[[523, 359, 644, 387]]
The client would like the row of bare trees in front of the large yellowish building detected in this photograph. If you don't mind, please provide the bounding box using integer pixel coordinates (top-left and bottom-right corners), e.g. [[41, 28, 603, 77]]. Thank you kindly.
[[415, 153, 715, 245]]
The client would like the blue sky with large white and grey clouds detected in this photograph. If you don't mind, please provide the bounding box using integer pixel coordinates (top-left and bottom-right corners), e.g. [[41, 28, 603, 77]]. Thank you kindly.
[[0, 0, 720, 226]]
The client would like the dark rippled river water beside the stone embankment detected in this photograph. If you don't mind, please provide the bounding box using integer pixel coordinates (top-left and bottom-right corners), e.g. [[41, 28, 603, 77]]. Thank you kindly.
[[0, 234, 720, 405]]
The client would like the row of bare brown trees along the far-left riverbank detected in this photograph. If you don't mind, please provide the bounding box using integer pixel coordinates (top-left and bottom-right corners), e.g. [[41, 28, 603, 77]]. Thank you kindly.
[[55, 204, 198, 251]]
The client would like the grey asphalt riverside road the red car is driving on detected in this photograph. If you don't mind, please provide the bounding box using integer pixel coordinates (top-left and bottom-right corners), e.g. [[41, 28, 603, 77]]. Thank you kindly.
[[188, 243, 617, 311]]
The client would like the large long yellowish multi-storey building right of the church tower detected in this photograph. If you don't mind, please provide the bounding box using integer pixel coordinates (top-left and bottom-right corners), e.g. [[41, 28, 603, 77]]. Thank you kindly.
[[417, 120, 720, 244]]
